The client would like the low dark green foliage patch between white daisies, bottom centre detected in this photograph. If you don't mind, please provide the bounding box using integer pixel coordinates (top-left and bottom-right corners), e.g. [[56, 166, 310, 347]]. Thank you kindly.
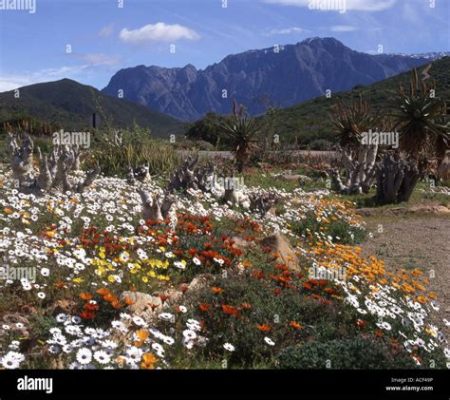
[[182, 268, 353, 368]]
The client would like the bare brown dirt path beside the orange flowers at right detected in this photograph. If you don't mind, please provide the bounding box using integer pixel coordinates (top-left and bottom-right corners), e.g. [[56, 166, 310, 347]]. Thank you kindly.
[[362, 214, 450, 338]]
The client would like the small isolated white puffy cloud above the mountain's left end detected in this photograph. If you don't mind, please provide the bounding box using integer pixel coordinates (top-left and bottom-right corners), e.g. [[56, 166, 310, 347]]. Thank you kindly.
[[119, 22, 200, 43]]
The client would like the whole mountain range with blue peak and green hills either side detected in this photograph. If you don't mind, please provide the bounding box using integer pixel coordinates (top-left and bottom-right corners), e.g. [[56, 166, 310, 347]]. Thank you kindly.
[[0, 38, 449, 138]]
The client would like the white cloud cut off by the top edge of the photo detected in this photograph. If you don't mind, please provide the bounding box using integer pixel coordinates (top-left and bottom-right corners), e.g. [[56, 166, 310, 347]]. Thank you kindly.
[[263, 0, 397, 11]]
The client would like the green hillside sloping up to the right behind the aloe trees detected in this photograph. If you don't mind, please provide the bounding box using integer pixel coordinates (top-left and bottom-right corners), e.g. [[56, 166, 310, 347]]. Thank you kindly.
[[263, 57, 450, 144]]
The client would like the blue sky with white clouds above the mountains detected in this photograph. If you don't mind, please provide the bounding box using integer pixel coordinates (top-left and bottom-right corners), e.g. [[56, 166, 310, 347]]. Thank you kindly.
[[0, 0, 450, 91]]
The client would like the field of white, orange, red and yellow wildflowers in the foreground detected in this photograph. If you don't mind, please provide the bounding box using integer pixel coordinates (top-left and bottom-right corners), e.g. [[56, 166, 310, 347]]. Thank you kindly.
[[0, 159, 450, 369]]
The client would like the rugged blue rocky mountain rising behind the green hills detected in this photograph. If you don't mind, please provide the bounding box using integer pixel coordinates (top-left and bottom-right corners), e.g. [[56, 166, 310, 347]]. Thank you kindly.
[[103, 38, 428, 121]]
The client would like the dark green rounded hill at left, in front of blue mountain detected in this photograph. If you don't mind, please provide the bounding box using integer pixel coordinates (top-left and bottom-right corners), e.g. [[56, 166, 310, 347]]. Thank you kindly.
[[0, 79, 182, 136]]
